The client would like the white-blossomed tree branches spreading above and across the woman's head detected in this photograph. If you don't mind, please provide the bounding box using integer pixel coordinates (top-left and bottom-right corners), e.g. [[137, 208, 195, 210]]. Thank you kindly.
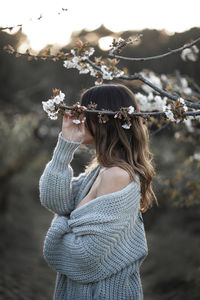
[[1, 21, 200, 209]]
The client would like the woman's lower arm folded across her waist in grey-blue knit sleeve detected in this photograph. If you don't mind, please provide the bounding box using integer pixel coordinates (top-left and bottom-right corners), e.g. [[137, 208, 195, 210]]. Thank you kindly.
[[43, 173, 142, 284]]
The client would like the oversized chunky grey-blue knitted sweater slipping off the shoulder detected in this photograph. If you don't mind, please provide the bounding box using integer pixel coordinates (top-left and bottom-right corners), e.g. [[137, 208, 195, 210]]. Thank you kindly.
[[39, 132, 148, 300]]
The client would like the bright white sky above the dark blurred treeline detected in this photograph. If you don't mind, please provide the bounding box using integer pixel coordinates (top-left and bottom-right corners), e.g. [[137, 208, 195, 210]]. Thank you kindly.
[[0, 0, 200, 52]]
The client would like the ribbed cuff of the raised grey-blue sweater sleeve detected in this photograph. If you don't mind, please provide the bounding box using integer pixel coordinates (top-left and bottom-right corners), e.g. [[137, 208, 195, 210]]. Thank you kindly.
[[51, 132, 81, 171]]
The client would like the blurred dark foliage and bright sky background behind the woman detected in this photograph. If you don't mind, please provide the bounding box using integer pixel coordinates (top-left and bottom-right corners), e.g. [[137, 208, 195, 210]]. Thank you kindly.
[[0, 1, 200, 300]]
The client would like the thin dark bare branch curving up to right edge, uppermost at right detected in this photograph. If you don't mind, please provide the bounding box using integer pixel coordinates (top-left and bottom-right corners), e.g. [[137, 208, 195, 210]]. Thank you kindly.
[[108, 37, 200, 61]]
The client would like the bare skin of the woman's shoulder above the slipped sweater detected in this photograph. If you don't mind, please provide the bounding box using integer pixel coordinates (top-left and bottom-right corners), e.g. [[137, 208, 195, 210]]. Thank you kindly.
[[97, 167, 131, 197]]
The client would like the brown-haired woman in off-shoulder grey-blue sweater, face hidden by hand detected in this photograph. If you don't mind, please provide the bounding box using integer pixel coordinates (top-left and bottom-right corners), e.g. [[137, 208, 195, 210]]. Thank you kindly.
[[40, 84, 157, 300]]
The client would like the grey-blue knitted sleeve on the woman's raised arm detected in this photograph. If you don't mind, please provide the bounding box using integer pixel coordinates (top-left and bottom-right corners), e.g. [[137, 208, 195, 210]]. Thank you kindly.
[[39, 132, 85, 215]]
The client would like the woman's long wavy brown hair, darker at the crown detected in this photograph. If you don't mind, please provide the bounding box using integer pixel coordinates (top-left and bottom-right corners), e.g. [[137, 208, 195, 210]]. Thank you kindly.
[[80, 84, 158, 212]]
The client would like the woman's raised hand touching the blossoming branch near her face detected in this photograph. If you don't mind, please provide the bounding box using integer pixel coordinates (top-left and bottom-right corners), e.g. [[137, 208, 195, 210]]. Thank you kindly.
[[62, 112, 85, 142]]
